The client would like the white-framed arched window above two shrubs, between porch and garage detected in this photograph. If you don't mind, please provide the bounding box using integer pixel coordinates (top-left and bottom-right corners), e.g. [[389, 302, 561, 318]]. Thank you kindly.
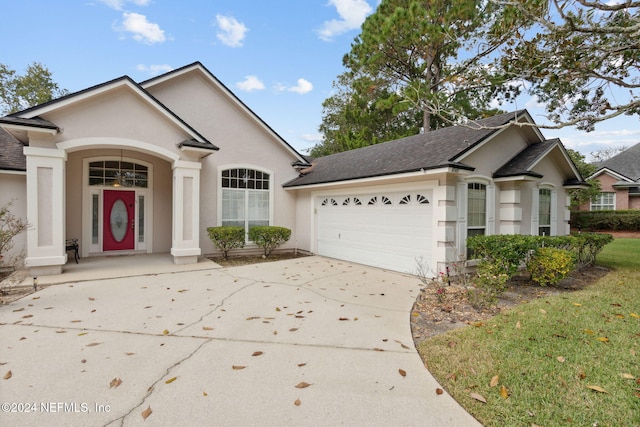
[[221, 168, 271, 232]]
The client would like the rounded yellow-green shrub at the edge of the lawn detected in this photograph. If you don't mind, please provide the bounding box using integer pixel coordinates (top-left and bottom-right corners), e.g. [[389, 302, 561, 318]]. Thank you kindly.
[[527, 247, 575, 286]]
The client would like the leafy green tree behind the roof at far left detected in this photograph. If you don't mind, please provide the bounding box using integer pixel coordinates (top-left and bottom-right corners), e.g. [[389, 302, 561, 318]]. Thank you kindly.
[[0, 62, 69, 114]]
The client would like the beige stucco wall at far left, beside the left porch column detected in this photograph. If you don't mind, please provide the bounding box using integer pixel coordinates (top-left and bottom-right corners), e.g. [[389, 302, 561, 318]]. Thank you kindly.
[[0, 172, 27, 265]]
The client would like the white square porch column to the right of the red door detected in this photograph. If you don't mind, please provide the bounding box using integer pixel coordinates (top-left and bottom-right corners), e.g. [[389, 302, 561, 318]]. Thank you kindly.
[[171, 160, 202, 264]]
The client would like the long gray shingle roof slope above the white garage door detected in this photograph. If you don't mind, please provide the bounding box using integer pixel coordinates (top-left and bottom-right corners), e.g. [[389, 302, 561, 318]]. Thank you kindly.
[[284, 110, 526, 187]]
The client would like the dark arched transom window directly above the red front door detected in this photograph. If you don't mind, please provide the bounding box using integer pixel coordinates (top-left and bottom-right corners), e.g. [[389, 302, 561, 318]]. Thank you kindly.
[[89, 160, 149, 188]]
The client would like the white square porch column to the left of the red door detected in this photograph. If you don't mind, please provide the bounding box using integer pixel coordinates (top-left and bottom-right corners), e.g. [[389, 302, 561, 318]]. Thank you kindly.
[[24, 147, 67, 276]]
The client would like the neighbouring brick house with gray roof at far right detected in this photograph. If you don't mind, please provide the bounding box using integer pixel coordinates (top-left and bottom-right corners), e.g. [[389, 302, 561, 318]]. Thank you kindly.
[[580, 143, 640, 211]]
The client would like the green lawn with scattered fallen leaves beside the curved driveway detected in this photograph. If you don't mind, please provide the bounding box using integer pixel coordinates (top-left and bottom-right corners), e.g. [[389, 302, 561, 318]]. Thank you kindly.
[[419, 239, 640, 426]]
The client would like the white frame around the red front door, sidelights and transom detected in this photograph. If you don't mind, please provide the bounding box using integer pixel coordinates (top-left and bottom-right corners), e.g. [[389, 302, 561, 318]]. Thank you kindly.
[[80, 156, 153, 256]]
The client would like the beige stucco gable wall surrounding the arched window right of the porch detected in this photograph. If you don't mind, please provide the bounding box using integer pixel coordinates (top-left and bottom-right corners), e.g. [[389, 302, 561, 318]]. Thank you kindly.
[[147, 73, 302, 254]]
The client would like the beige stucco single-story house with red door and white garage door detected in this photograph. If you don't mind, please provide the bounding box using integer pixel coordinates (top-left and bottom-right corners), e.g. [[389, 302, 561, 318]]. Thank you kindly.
[[0, 62, 584, 275]]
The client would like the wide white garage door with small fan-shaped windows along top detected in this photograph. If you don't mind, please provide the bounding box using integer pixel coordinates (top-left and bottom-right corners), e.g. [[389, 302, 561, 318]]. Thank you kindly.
[[316, 190, 433, 274]]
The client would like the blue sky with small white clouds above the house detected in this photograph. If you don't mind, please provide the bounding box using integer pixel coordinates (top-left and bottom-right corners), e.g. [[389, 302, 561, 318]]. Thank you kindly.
[[0, 0, 640, 159]]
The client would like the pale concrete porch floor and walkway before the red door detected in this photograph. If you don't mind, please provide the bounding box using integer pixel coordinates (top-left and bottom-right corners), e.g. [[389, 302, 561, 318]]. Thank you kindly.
[[6, 253, 221, 286]]
